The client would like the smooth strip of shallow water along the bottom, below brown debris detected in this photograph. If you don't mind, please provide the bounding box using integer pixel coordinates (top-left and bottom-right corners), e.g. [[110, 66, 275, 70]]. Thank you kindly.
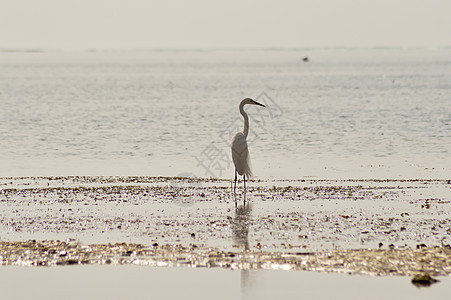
[[0, 266, 450, 300]]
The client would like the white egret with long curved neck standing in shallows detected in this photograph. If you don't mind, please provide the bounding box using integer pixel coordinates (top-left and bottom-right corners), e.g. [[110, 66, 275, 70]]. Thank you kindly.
[[232, 98, 265, 205]]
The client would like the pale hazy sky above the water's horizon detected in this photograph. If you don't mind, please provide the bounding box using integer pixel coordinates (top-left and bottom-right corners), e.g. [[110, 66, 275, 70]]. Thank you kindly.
[[0, 0, 451, 49]]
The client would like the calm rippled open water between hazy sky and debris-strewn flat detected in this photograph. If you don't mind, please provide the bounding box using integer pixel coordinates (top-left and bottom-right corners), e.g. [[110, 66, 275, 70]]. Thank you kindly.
[[0, 49, 451, 179]]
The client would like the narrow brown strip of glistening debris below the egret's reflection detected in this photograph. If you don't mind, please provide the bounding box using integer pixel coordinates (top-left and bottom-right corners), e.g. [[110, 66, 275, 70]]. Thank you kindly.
[[0, 240, 451, 276]]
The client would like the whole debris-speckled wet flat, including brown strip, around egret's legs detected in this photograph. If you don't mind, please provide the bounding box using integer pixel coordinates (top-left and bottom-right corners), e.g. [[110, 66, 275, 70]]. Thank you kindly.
[[0, 177, 451, 275]]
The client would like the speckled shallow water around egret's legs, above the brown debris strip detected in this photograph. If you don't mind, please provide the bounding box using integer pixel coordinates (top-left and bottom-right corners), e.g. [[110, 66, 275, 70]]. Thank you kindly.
[[0, 177, 451, 251]]
